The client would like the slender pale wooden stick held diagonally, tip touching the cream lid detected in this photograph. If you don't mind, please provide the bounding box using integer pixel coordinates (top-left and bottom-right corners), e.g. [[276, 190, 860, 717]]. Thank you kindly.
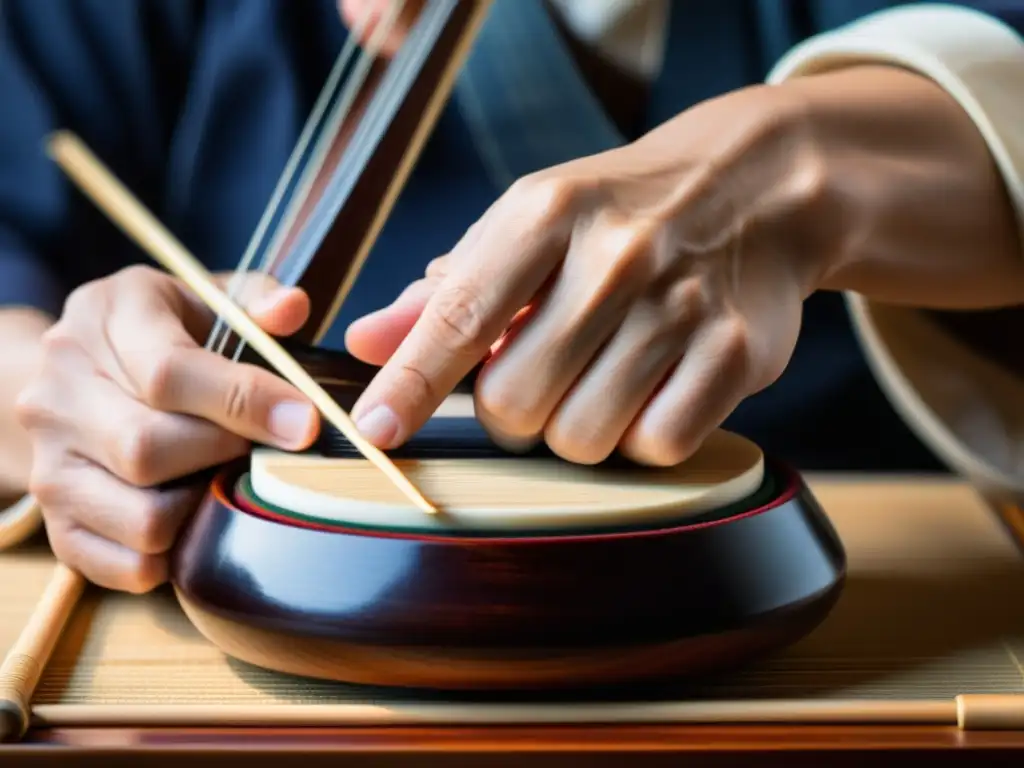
[[47, 131, 437, 514]]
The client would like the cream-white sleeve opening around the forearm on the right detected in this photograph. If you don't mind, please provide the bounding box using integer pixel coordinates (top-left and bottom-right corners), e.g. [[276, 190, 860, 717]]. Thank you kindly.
[[768, 4, 1024, 505]]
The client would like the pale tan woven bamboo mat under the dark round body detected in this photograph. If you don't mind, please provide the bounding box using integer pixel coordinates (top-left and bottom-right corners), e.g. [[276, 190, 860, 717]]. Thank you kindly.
[[0, 479, 1024, 706]]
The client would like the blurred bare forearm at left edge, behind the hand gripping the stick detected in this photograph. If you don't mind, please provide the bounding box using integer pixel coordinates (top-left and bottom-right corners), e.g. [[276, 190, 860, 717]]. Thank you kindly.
[[0, 308, 52, 499]]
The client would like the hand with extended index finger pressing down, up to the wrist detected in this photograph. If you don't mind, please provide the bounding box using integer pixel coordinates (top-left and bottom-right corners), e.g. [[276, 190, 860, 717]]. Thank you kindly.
[[347, 81, 837, 465]]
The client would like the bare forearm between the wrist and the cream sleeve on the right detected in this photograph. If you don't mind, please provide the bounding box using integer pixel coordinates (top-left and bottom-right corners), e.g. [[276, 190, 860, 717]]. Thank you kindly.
[[780, 65, 1024, 308]]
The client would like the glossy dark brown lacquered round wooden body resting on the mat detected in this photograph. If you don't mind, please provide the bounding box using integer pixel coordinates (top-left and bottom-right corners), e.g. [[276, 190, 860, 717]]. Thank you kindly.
[[167, 464, 846, 688]]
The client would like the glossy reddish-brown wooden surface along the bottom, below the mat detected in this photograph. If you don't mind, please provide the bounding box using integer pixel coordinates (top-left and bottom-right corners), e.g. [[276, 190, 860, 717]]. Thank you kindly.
[[0, 477, 1024, 768]]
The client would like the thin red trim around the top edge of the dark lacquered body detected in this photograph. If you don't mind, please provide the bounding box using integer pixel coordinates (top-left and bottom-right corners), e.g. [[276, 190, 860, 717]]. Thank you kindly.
[[211, 462, 800, 546]]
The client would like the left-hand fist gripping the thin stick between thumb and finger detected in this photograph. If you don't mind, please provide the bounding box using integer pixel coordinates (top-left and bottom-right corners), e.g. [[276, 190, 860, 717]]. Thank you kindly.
[[16, 267, 318, 593]]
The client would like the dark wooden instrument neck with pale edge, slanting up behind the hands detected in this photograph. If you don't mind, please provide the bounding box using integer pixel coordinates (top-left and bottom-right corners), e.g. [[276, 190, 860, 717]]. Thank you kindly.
[[271, 0, 489, 345]]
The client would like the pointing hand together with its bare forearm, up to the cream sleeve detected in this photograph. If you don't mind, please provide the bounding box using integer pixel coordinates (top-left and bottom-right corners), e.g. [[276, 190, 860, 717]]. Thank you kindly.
[[346, 68, 1024, 465]]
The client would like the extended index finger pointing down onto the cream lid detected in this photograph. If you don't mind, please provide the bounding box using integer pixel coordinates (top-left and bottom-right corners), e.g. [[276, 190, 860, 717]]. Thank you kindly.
[[353, 186, 568, 450]]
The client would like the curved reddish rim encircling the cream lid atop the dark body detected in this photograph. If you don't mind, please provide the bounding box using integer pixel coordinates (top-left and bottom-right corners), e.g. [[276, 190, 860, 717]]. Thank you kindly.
[[216, 456, 801, 546]]
